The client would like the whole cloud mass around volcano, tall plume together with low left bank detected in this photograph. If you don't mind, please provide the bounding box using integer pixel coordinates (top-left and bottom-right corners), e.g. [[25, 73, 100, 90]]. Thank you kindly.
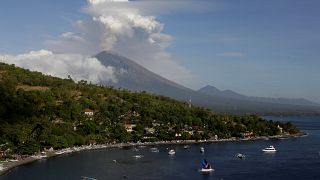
[[0, 0, 206, 84]]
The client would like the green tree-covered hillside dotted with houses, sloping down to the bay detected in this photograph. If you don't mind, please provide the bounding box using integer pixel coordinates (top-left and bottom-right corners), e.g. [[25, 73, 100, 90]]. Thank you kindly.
[[0, 63, 299, 154]]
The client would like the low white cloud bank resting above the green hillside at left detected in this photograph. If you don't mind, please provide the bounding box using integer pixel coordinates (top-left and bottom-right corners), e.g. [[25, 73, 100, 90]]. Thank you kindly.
[[0, 50, 116, 83]]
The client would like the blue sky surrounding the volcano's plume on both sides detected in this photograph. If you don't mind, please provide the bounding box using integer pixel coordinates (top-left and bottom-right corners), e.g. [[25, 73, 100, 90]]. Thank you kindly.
[[0, 0, 320, 103]]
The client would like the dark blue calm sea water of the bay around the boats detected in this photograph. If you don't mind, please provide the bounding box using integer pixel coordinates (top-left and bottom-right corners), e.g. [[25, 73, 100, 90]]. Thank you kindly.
[[0, 116, 320, 180]]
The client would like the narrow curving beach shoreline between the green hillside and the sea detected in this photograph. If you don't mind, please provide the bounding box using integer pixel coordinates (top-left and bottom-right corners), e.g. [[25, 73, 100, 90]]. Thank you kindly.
[[0, 132, 308, 176]]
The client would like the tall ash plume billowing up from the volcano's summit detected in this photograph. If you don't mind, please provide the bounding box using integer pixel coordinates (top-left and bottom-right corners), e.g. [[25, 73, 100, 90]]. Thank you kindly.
[[47, 0, 201, 84]]
